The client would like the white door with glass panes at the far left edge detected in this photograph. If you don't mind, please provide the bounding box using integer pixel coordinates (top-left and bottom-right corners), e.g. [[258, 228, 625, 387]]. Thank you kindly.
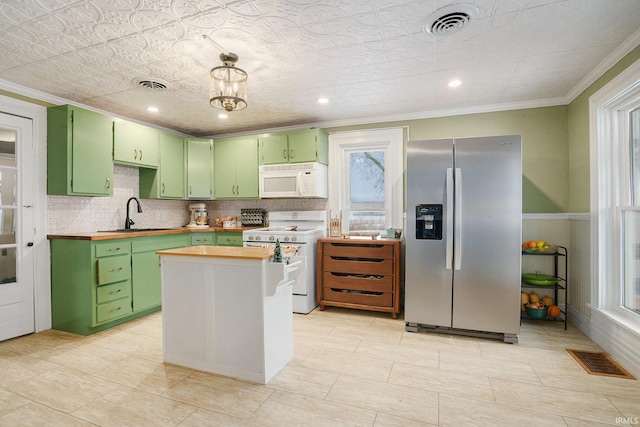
[[0, 113, 35, 341]]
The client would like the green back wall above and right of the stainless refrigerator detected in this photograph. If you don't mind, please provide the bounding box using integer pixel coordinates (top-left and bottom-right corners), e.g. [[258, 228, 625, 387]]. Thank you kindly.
[[327, 105, 569, 213]]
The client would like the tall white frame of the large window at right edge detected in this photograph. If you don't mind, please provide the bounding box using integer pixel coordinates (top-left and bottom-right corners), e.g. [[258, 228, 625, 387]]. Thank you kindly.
[[589, 57, 640, 332]]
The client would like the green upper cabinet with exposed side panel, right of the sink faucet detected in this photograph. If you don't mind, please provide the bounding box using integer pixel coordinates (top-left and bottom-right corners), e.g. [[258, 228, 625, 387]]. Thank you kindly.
[[139, 132, 185, 199]]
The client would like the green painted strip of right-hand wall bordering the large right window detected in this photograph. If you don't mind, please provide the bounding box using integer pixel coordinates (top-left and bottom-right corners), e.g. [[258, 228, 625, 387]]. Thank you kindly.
[[568, 46, 640, 212]]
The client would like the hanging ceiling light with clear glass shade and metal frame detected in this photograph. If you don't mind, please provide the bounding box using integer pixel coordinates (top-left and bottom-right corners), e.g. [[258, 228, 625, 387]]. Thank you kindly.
[[209, 53, 247, 111]]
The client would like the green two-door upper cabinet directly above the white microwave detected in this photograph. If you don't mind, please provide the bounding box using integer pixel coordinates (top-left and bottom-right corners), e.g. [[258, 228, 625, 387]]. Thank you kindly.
[[258, 129, 329, 165]]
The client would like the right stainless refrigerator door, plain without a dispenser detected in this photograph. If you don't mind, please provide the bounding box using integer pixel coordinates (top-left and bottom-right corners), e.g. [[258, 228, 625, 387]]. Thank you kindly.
[[452, 136, 522, 334]]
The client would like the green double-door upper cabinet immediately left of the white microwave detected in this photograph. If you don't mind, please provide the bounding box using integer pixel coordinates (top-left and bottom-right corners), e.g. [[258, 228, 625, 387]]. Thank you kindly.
[[213, 137, 259, 199]]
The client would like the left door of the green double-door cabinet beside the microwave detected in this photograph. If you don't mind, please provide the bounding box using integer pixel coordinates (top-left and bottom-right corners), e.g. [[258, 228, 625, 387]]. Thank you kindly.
[[213, 138, 242, 199]]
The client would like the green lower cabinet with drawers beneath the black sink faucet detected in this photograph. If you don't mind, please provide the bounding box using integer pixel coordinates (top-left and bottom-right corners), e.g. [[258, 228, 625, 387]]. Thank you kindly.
[[50, 234, 189, 335]]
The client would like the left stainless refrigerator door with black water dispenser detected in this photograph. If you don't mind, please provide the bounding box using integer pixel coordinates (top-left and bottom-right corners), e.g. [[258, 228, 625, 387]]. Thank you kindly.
[[404, 139, 453, 327]]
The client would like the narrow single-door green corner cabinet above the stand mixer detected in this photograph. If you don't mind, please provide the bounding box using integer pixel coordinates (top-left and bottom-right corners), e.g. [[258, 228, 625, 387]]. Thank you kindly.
[[185, 138, 213, 200]]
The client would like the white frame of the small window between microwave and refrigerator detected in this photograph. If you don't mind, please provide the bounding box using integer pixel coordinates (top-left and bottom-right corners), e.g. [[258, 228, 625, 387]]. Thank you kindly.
[[327, 128, 404, 233]]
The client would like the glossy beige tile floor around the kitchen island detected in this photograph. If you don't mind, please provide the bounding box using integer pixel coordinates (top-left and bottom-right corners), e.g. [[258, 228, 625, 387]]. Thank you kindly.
[[0, 308, 640, 427]]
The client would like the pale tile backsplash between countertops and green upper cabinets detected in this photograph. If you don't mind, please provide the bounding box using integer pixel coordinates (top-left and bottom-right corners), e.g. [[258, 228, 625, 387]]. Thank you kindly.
[[47, 166, 327, 234]]
